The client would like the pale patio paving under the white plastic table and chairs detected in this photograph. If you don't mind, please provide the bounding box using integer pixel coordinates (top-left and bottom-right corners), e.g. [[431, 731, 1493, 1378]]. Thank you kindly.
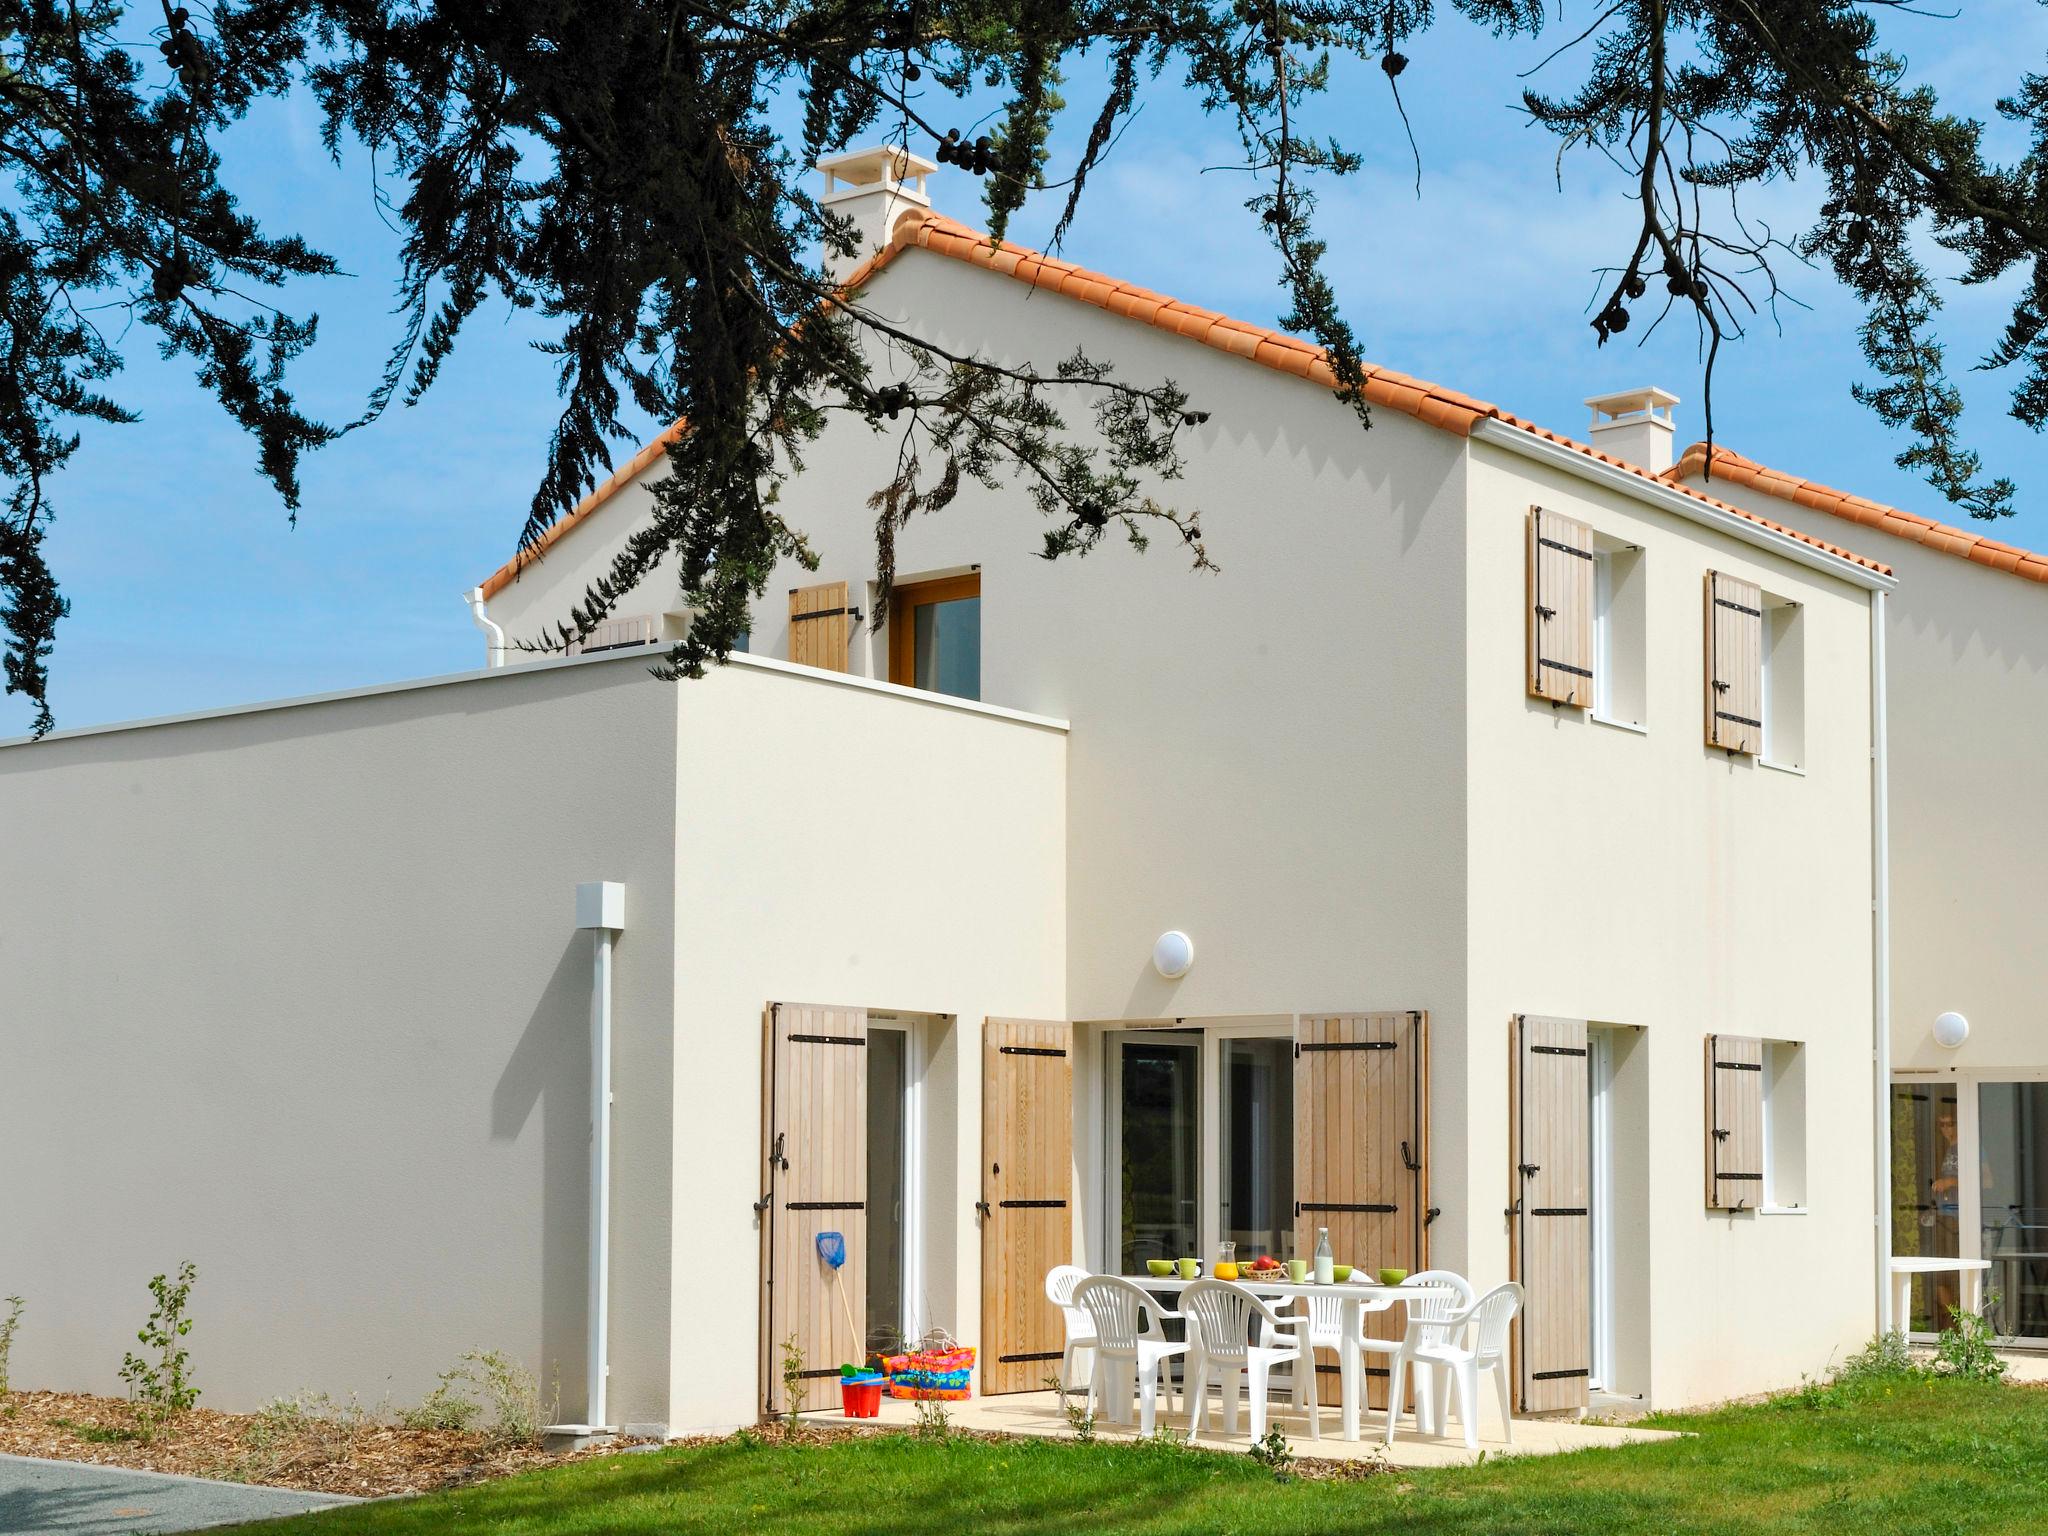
[[805, 1393, 1679, 1466]]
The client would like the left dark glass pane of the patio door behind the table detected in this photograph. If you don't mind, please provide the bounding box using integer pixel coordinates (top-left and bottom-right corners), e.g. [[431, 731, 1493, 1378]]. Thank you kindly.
[[1114, 1036, 1202, 1274]]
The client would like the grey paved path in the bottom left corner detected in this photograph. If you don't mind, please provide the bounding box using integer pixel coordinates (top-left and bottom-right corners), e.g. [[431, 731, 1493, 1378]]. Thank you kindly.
[[0, 1456, 354, 1536]]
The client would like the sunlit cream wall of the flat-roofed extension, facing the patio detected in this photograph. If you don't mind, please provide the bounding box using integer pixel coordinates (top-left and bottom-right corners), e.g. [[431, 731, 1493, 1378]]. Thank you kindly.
[[655, 662, 1067, 1434]]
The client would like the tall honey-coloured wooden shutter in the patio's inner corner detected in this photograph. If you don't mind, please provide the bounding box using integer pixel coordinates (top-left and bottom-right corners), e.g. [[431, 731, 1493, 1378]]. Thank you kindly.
[[979, 1018, 1073, 1395]]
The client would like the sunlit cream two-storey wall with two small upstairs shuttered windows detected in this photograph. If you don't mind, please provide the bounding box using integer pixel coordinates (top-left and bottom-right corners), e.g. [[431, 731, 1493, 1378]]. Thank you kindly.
[[1464, 444, 1876, 1405]]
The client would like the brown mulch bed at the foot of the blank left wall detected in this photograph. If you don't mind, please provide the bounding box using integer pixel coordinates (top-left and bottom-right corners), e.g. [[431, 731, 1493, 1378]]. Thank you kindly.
[[0, 1393, 647, 1499]]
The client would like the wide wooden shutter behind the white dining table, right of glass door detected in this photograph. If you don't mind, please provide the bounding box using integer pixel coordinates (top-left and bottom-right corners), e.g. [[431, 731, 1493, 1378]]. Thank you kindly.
[[1294, 1012, 1432, 1407]]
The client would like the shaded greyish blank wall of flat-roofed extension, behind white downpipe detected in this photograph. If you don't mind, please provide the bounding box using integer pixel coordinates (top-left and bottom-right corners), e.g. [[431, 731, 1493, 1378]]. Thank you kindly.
[[0, 659, 678, 1421]]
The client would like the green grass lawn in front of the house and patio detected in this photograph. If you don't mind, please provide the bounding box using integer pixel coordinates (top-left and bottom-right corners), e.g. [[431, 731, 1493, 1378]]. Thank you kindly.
[[228, 1380, 2048, 1536]]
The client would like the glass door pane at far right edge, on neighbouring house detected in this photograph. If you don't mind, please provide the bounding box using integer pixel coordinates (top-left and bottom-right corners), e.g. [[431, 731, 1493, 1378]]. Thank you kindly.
[[1976, 1083, 2048, 1339]]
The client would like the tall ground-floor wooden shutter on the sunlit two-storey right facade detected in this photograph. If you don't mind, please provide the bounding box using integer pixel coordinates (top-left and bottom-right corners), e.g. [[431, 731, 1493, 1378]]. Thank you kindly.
[[1507, 1014, 1593, 1413]]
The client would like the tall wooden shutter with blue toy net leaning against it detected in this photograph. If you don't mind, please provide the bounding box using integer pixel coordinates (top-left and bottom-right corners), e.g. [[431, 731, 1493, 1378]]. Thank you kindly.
[[762, 1004, 868, 1417]]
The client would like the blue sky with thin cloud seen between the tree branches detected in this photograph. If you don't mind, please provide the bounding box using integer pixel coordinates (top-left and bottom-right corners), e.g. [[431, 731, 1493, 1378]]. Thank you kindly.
[[0, 0, 2048, 735]]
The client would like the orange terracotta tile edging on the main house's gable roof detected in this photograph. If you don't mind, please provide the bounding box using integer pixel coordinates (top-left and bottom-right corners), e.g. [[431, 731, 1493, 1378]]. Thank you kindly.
[[483, 211, 1884, 598]]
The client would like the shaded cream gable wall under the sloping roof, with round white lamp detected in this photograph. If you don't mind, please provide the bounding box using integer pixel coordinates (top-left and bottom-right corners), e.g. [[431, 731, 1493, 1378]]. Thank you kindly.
[[479, 252, 1464, 1264]]
